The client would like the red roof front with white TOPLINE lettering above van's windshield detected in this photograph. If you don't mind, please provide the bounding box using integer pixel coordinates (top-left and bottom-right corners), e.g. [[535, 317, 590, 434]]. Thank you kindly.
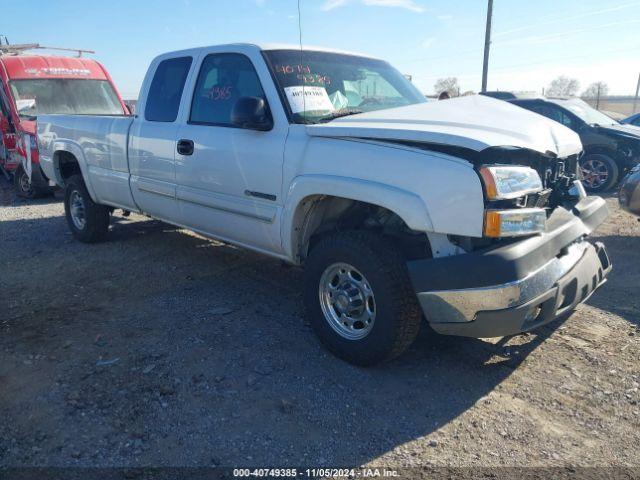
[[0, 55, 108, 80]]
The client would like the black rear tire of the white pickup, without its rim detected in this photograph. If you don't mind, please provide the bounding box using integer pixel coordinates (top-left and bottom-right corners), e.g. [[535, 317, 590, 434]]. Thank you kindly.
[[64, 175, 110, 243]]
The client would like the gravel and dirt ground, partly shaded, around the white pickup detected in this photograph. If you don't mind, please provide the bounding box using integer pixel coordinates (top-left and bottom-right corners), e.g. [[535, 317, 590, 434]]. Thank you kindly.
[[0, 180, 640, 472]]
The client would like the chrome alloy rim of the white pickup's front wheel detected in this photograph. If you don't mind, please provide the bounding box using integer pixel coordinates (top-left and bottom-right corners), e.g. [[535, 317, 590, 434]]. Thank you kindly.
[[319, 263, 376, 340]]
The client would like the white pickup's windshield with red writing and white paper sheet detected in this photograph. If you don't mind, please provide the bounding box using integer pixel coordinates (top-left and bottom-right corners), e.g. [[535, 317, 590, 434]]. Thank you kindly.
[[264, 50, 426, 123]]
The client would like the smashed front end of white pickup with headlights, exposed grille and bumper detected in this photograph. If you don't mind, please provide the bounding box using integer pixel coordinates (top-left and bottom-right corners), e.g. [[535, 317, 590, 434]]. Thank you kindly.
[[408, 142, 611, 337]]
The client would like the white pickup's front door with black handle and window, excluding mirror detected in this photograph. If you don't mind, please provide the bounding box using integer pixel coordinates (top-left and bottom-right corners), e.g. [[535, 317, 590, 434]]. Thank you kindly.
[[176, 53, 288, 253]]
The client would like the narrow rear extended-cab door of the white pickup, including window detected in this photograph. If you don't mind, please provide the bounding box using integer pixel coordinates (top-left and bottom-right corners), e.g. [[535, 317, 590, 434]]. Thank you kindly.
[[128, 56, 193, 223]]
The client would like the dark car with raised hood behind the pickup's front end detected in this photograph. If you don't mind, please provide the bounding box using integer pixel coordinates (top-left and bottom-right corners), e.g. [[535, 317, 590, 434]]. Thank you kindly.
[[507, 98, 640, 192]]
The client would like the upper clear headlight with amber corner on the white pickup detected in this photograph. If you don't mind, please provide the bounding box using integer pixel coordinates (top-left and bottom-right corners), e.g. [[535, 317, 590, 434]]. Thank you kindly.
[[480, 165, 542, 200]]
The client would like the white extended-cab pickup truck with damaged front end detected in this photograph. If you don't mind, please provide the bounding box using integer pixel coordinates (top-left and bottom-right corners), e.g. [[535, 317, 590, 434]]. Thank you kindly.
[[38, 44, 611, 365]]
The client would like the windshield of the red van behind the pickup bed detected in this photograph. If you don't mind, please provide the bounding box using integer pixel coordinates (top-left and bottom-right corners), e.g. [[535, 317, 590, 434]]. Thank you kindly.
[[10, 78, 124, 120]]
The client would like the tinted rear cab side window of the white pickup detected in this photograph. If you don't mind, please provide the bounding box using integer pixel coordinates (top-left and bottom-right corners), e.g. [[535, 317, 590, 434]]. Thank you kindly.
[[144, 57, 193, 122]]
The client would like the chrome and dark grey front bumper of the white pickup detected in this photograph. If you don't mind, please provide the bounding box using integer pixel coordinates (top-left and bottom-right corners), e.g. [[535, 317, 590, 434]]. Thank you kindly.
[[409, 197, 611, 337]]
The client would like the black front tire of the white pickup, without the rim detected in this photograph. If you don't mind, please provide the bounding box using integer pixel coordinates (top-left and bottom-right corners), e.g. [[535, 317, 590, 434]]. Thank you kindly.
[[304, 231, 421, 366]]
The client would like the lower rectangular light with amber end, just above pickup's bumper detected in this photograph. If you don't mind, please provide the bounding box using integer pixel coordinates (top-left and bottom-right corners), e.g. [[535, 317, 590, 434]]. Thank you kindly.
[[484, 208, 547, 238]]
